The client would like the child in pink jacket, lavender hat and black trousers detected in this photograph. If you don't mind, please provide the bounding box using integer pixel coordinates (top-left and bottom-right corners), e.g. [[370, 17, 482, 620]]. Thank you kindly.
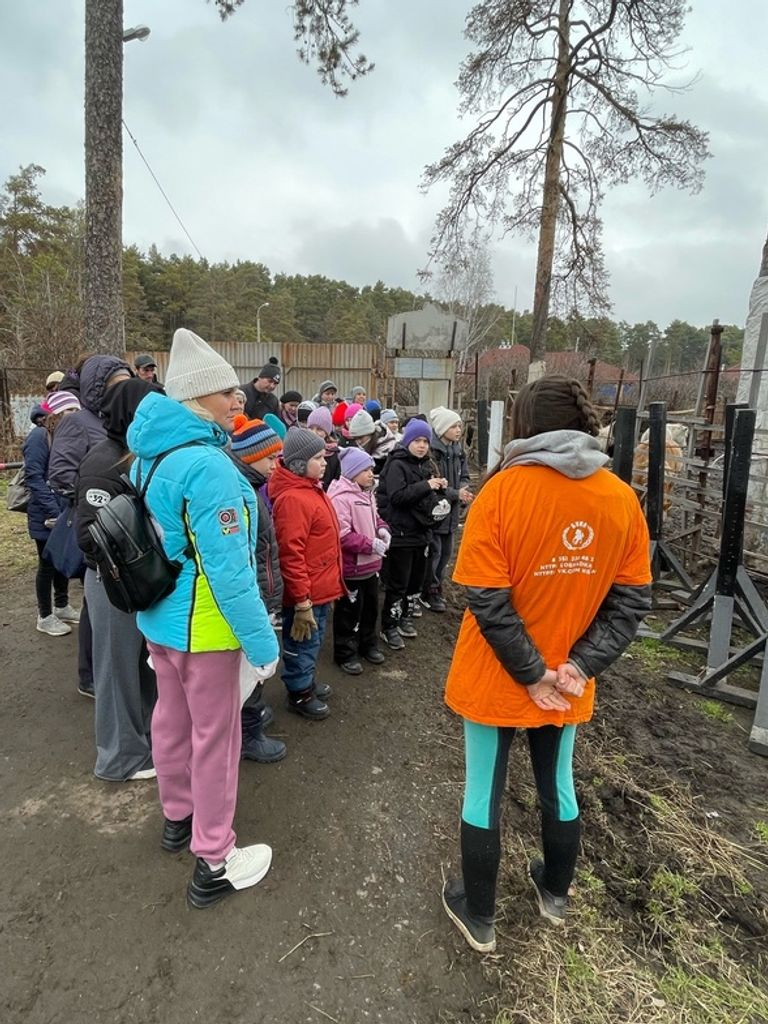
[[328, 447, 391, 676]]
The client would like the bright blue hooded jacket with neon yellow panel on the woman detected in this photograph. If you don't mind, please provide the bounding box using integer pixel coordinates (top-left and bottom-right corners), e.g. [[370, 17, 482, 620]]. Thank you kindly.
[[127, 394, 280, 665]]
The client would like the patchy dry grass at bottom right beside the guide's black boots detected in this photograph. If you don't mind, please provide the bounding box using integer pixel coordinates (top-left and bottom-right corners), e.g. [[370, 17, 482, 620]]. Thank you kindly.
[[485, 733, 768, 1024]]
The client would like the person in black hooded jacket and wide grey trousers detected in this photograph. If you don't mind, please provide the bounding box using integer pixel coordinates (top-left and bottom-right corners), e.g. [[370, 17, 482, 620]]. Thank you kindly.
[[75, 379, 163, 782]]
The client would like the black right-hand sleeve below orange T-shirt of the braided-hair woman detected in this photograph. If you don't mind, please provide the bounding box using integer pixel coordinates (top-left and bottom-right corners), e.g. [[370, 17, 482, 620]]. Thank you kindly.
[[568, 584, 651, 679]]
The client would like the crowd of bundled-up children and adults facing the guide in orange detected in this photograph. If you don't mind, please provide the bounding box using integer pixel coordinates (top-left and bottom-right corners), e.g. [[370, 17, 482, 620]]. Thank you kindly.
[[25, 329, 472, 906]]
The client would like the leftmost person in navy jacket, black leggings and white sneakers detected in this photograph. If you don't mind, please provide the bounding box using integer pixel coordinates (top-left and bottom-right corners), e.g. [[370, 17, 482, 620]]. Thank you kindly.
[[22, 406, 72, 636]]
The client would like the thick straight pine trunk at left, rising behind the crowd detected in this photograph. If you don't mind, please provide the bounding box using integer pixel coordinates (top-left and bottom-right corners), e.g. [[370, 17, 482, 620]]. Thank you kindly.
[[85, 0, 125, 355]]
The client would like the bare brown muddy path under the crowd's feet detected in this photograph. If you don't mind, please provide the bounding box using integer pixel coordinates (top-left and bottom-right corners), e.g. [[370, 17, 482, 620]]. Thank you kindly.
[[0, 581, 488, 1024]]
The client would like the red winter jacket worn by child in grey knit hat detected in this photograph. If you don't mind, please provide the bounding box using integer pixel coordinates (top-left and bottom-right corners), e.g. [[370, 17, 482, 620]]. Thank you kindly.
[[267, 461, 346, 606]]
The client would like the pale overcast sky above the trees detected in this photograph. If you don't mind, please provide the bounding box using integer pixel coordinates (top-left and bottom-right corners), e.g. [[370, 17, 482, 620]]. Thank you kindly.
[[0, 0, 768, 327]]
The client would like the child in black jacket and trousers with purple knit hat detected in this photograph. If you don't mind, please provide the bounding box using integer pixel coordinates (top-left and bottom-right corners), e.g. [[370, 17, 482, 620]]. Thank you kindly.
[[376, 419, 451, 650]]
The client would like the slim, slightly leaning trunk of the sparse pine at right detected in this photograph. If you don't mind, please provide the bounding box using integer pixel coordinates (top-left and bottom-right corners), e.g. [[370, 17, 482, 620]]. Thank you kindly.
[[530, 0, 570, 359]]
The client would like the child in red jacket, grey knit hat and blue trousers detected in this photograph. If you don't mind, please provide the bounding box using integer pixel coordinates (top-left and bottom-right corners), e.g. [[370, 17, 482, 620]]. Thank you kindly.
[[268, 427, 344, 719]]
